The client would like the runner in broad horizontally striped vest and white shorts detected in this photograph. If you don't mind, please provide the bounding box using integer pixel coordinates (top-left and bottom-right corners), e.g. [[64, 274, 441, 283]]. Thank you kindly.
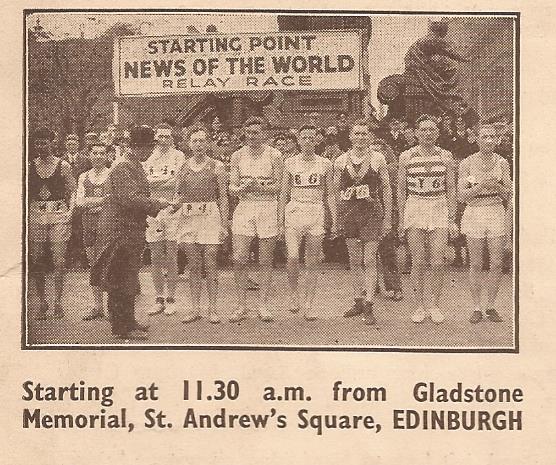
[[398, 115, 457, 324]]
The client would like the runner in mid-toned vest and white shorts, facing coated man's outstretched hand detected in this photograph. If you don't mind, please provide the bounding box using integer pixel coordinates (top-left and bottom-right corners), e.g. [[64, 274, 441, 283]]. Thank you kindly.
[[175, 127, 228, 323]]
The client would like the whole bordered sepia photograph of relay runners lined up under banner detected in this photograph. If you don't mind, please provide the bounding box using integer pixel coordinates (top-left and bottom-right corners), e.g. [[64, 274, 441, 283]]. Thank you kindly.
[[22, 10, 519, 352]]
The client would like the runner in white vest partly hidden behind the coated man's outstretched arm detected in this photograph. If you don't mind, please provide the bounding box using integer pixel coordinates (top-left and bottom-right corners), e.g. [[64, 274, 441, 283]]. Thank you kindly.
[[143, 124, 185, 315]]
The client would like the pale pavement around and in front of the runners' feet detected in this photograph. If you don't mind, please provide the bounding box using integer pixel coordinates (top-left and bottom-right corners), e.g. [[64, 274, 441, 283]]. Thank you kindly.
[[25, 266, 514, 349]]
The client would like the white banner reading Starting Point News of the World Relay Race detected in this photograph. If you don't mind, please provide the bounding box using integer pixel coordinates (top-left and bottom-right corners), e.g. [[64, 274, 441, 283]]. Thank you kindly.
[[114, 30, 363, 97]]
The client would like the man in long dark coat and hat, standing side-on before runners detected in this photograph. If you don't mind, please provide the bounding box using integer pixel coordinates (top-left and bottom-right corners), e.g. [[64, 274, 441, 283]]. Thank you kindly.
[[91, 126, 170, 340]]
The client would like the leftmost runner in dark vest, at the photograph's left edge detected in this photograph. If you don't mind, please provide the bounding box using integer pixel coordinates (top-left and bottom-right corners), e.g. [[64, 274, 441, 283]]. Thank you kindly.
[[28, 128, 75, 320]]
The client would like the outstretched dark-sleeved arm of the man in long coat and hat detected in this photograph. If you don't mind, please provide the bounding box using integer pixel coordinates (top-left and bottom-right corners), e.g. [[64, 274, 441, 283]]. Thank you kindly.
[[109, 163, 169, 216]]
